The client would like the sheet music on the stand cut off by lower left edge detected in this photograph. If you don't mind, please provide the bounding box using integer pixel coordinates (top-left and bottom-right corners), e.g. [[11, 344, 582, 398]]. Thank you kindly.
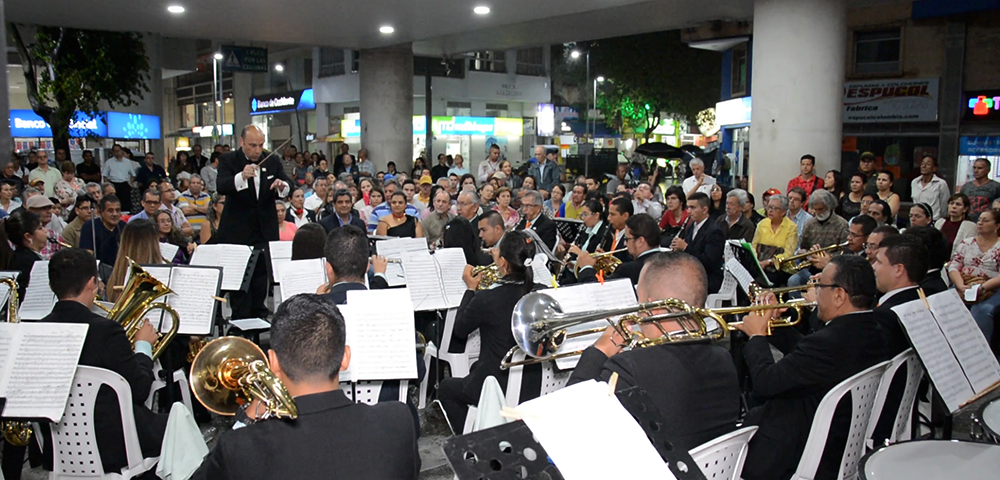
[[0, 323, 89, 421]]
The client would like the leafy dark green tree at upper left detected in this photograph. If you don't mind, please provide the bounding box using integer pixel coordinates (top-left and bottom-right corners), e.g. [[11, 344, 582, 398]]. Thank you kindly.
[[8, 24, 149, 152]]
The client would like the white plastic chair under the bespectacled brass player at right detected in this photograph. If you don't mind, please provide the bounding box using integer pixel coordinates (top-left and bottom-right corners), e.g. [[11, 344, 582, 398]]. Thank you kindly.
[[792, 360, 890, 480]]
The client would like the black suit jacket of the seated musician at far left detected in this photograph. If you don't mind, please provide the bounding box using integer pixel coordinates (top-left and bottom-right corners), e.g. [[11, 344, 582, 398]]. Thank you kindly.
[[42, 301, 167, 472]]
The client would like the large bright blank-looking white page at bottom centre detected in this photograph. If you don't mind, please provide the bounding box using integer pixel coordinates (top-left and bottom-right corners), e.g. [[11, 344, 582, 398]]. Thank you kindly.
[[517, 380, 675, 480]]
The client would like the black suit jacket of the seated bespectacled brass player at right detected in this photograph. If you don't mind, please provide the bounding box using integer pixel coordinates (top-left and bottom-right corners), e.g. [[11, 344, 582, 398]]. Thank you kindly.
[[743, 312, 889, 480]]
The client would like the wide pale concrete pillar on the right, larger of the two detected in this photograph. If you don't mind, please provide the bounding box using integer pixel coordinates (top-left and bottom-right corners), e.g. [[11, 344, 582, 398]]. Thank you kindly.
[[749, 0, 847, 195]]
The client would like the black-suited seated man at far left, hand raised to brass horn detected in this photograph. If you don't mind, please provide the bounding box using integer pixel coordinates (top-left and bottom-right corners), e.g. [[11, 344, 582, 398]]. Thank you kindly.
[[42, 248, 167, 473]]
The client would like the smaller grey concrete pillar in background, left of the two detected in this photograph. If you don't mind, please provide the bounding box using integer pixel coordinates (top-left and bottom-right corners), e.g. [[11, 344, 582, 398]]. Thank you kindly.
[[358, 43, 413, 171]]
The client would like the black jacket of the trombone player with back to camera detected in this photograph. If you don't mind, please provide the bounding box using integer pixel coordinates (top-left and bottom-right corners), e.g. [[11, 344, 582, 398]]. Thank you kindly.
[[569, 342, 740, 450]]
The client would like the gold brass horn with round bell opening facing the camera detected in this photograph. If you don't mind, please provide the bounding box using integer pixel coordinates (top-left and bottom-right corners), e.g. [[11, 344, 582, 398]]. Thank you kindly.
[[190, 337, 298, 419]]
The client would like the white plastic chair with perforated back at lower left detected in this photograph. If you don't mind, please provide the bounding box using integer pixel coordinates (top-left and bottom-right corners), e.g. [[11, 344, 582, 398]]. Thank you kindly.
[[49, 366, 160, 480]]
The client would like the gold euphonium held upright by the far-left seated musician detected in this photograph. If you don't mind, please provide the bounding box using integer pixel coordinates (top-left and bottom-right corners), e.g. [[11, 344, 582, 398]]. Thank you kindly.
[[102, 257, 181, 361]]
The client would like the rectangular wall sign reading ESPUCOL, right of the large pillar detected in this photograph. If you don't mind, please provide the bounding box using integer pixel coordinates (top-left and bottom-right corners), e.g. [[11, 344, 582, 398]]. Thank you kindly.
[[844, 78, 938, 123]]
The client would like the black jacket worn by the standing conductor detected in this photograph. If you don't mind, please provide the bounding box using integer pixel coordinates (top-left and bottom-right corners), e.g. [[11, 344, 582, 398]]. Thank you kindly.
[[215, 148, 292, 246]]
